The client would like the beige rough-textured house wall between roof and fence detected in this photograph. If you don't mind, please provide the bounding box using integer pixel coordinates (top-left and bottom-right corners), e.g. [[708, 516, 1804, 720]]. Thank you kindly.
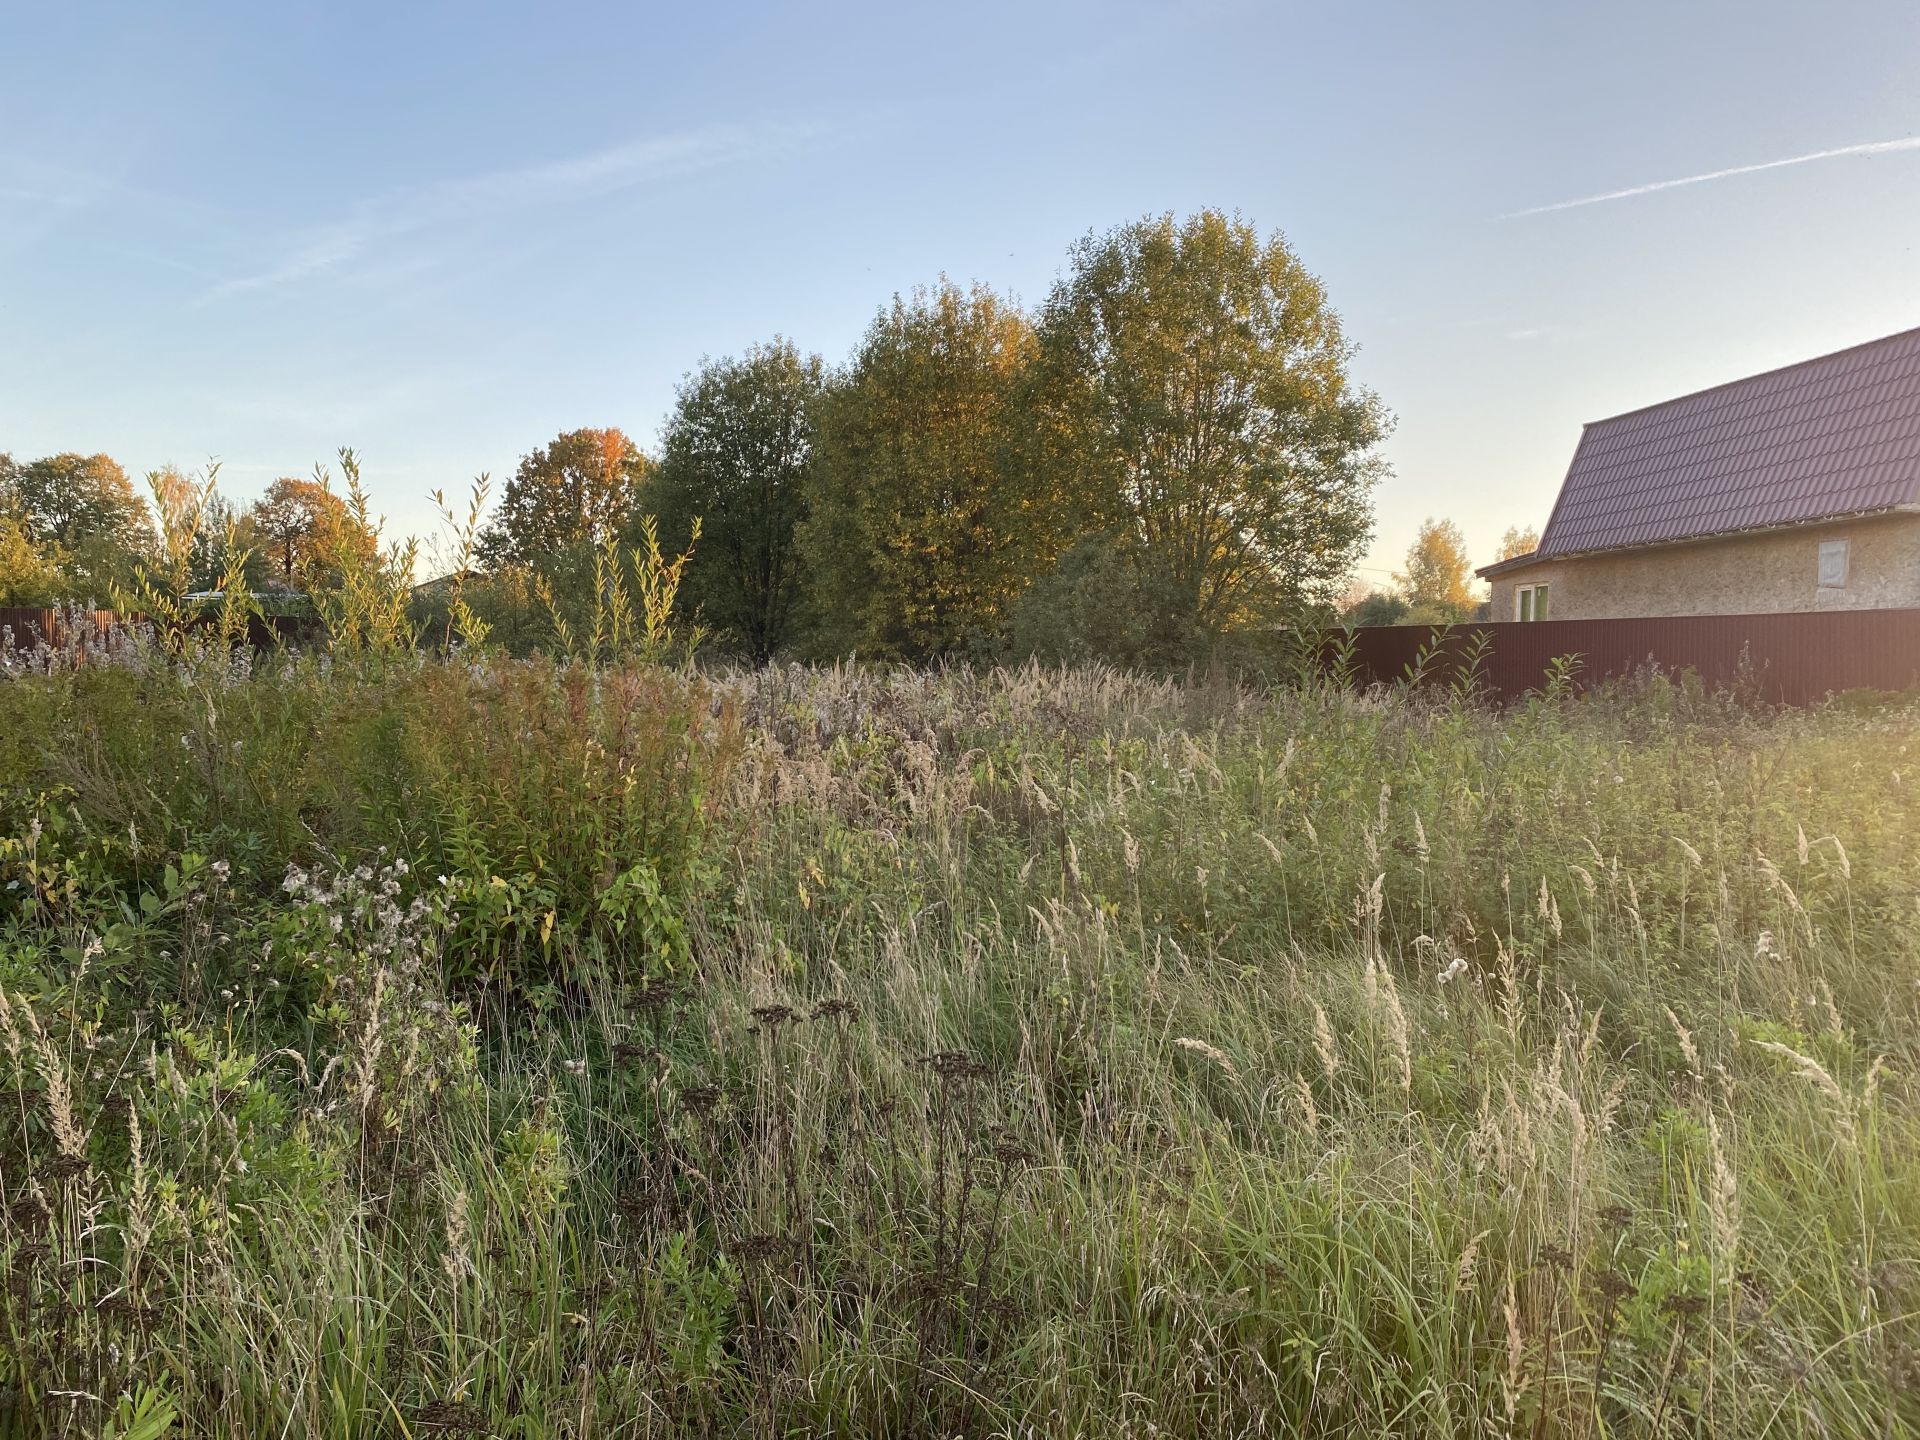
[[1490, 515, 1920, 620]]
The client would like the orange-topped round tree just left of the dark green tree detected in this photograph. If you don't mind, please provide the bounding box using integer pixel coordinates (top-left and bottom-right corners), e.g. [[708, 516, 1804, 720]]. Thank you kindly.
[[478, 428, 647, 568]]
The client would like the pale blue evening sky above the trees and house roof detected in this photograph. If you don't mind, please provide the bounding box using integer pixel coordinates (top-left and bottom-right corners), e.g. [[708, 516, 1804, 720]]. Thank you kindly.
[[0, 0, 1920, 578]]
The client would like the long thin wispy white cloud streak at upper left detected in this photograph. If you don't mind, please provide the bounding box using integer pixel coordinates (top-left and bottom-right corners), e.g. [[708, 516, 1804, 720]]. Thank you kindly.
[[204, 125, 814, 301]]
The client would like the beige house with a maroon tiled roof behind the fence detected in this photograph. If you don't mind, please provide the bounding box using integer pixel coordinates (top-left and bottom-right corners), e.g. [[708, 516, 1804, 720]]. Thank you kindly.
[[1478, 330, 1920, 620]]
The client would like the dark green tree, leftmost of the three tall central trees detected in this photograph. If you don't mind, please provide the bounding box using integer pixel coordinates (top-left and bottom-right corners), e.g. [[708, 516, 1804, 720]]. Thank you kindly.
[[643, 340, 824, 660]]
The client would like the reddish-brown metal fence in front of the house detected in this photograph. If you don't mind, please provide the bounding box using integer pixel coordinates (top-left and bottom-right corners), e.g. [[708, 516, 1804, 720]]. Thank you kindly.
[[1328, 611, 1920, 705]]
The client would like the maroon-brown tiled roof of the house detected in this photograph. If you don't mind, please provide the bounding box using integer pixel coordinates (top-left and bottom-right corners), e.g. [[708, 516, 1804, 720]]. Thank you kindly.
[[1536, 330, 1920, 559]]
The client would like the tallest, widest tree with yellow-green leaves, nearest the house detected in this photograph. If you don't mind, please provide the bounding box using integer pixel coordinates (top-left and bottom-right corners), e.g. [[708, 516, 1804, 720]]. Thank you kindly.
[[1033, 211, 1388, 634]]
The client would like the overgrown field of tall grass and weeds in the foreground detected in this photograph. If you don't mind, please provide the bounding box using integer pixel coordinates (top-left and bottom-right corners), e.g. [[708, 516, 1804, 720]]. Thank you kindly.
[[0, 651, 1920, 1440]]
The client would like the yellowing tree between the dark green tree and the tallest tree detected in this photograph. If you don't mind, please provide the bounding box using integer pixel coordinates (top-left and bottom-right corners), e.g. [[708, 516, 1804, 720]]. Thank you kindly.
[[801, 280, 1068, 659]]
